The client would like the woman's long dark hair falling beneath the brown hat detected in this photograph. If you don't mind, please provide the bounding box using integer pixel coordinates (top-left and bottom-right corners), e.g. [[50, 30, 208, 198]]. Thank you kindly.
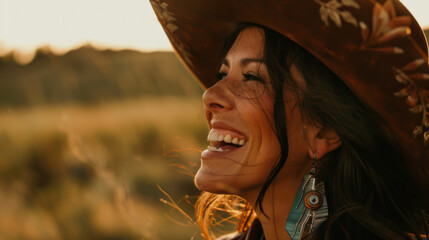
[[199, 23, 427, 239]]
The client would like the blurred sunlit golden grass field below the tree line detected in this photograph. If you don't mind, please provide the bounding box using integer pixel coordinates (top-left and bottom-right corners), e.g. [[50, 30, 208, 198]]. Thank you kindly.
[[0, 97, 207, 240]]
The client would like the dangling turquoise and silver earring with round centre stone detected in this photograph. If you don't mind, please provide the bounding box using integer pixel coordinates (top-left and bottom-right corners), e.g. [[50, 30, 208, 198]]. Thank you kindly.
[[286, 153, 328, 240]]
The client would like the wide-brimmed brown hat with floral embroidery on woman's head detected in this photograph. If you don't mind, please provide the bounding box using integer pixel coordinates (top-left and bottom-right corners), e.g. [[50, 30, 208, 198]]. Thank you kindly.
[[150, 0, 429, 202]]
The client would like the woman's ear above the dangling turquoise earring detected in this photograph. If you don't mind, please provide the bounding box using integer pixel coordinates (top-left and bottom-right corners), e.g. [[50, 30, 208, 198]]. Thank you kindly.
[[307, 126, 341, 159]]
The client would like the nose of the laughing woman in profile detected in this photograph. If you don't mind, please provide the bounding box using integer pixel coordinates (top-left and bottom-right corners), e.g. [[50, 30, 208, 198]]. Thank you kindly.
[[203, 80, 233, 113]]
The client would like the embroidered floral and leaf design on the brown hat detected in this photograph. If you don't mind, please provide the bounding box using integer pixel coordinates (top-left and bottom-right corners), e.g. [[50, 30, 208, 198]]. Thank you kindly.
[[314, 0, 429, 144]]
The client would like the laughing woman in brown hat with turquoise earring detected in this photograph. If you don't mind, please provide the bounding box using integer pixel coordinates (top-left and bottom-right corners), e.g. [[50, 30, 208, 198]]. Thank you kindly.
[[152, 0, 429, 239]]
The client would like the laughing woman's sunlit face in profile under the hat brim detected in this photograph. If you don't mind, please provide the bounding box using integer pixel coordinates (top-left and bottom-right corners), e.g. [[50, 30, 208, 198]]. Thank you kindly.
[[195, 27, 307, 195]]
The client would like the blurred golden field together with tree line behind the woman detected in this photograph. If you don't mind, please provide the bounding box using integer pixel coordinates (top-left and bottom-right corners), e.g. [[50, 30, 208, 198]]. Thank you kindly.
[[0, 30, 429, 240]]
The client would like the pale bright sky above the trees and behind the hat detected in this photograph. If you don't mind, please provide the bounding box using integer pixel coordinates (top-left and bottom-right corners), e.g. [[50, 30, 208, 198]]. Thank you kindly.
[[0, 0, 429, 57]]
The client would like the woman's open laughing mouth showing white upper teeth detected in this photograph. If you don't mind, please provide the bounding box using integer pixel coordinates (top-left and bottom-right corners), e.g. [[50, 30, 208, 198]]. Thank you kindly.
[[207, 129, 247, 152]]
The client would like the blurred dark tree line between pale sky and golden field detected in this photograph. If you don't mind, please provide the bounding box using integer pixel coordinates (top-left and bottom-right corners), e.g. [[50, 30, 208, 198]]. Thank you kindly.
[[0, 45, 202, 107]]
